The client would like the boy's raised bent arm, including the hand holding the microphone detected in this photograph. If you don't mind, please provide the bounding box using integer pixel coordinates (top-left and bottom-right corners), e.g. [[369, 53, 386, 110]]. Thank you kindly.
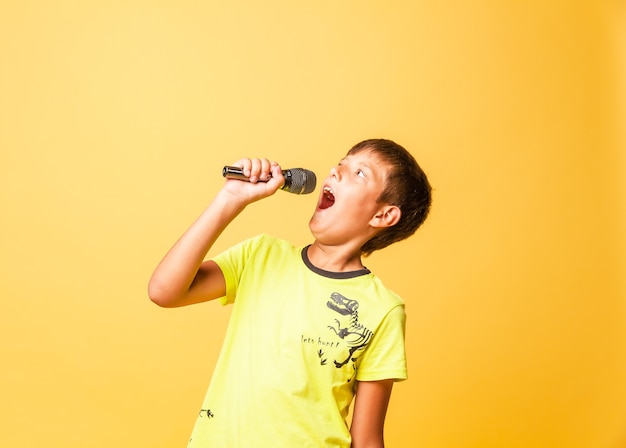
[[148, 159, 284, 308]]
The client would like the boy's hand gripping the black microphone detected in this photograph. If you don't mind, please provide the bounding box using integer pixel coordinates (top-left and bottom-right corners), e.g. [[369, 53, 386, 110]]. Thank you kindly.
[[224, 158, 285, 203]]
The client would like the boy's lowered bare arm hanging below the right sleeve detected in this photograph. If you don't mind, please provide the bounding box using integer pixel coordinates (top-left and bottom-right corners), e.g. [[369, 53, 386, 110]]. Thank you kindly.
[[350, 380, 393, 448]]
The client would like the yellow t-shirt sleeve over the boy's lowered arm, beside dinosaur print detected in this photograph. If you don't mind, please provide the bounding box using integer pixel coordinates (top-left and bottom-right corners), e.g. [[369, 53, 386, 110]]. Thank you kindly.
[[356, 305, 407, 381]]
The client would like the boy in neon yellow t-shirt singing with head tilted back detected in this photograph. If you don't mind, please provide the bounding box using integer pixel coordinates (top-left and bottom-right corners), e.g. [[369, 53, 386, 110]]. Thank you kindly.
[[149, 139, 431, 448]]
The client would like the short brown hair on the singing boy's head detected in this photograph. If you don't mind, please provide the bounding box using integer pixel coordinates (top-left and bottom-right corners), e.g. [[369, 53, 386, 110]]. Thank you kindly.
[[348, 139, 431, 256]]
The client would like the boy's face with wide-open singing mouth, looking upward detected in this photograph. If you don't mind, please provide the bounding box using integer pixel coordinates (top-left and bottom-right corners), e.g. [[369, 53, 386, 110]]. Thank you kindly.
[[309, 149, 389, 247]]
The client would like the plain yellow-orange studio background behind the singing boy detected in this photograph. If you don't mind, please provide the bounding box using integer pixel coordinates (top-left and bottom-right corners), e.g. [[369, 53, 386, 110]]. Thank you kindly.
[[0, 0, 626, 448]]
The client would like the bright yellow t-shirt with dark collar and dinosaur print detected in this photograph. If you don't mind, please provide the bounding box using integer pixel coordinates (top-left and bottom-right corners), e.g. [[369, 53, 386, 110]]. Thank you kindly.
[[189, 235, 407, 448]]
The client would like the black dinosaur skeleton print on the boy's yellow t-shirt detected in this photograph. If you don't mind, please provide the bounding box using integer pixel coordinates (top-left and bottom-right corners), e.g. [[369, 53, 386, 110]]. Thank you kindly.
[[326, 292, 373, 369]]
